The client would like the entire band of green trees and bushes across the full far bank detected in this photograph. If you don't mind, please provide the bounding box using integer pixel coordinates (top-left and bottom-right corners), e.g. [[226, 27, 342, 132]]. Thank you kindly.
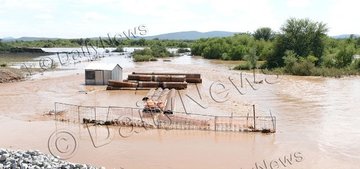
[[0, 18, 360, 76]]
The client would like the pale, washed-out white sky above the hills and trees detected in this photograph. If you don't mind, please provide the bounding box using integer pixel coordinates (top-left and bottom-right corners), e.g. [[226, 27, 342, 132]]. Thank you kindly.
[[0, 0, 360, 38]]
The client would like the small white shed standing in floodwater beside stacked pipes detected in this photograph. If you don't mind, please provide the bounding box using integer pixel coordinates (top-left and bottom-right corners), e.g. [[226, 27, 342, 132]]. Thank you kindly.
[[85, 63, 122, 85]]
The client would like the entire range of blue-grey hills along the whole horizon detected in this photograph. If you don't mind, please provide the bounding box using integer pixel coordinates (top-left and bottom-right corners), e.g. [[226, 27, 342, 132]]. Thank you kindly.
[[1, 31, 360, 42]]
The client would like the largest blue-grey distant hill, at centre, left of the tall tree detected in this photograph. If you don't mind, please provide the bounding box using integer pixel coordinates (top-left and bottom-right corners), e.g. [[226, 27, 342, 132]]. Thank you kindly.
[[144, 31, 236, 40]]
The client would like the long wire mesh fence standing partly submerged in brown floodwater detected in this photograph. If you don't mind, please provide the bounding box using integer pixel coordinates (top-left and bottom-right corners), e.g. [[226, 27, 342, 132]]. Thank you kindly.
[[55, 102, 276, 133]]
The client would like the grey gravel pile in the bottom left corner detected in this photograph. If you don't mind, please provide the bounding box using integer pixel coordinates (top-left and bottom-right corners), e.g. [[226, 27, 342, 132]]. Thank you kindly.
[[0, 149, 102, 169]]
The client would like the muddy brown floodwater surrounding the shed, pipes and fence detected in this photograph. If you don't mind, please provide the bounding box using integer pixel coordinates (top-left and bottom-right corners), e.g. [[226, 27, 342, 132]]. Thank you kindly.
[[0, 51, 360, 169]]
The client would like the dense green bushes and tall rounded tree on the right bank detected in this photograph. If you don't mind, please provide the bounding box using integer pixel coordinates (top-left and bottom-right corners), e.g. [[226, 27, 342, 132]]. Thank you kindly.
[[191, 18, 360, 76]]
